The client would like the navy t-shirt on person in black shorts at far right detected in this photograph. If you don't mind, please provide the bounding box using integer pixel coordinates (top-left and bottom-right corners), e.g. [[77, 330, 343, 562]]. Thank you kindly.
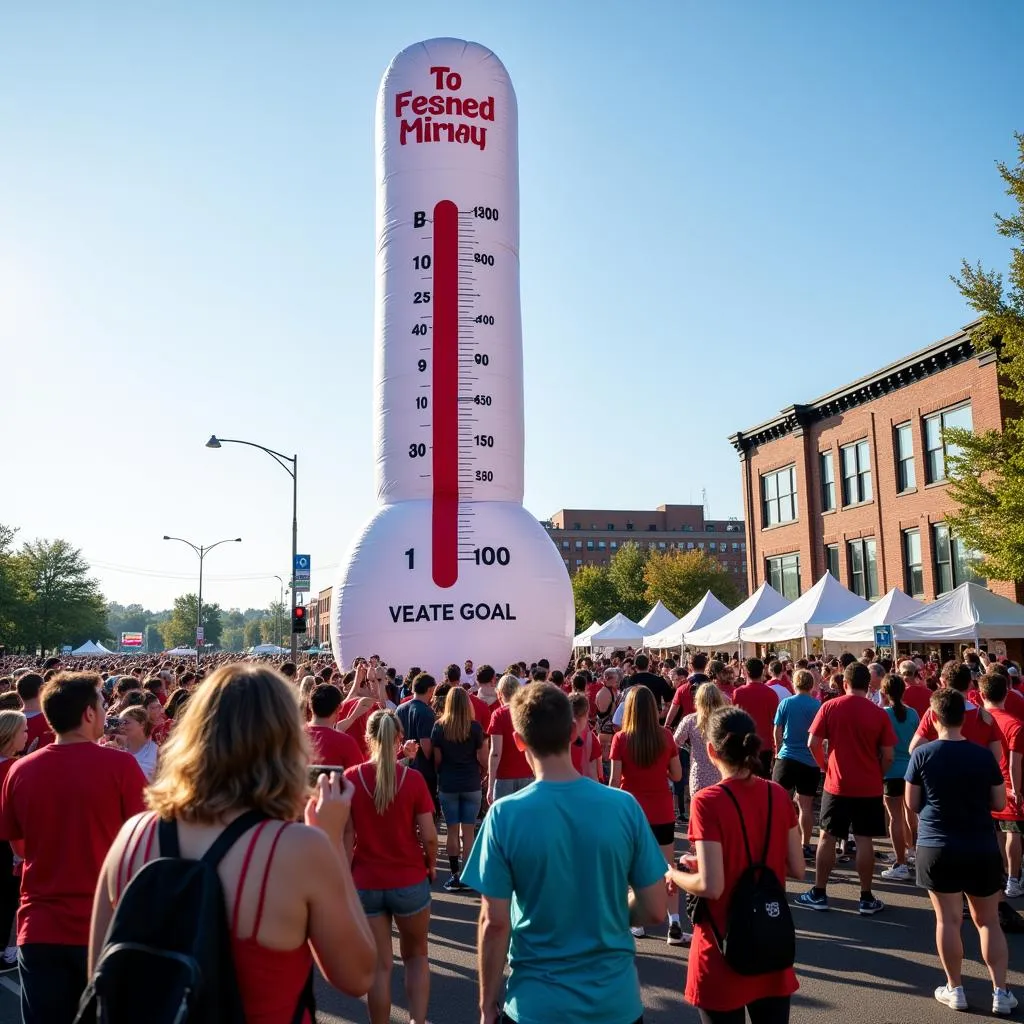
[[905, 739, 1002, 853]]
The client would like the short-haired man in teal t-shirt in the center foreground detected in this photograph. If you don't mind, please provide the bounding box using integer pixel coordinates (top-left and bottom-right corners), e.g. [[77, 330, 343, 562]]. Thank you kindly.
[[462, 683, 668, 1024]]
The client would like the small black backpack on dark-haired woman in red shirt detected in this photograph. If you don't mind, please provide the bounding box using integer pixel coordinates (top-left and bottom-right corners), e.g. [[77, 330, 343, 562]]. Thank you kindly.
[[702, 782, 797, 976]]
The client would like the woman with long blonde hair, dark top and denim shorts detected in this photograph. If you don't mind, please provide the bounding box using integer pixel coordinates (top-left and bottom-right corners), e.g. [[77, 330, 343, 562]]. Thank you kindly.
[[430, 686, 487, 893]]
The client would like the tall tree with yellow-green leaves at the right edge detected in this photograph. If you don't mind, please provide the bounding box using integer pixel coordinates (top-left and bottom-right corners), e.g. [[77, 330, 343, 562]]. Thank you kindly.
[[943, 133, 1024, 581]]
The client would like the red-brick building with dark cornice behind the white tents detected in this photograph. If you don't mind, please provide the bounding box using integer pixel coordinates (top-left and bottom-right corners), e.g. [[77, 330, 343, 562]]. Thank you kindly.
[[729, 325, 1024, 601]]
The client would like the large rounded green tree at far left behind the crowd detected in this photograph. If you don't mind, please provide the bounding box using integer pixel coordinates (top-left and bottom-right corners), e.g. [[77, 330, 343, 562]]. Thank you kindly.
[[17, 540, 106, 650]]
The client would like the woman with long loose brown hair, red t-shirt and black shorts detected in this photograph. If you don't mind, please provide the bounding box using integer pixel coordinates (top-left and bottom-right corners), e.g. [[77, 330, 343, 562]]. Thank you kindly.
[[608, 684, 688, 946]]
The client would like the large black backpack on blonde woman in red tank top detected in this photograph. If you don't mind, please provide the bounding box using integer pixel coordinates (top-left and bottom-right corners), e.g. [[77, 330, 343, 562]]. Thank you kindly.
[[75, 811, 315, 1024]]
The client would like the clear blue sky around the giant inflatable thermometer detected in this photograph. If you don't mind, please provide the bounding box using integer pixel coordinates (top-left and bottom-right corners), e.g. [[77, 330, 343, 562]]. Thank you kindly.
[[0, 0, 1024, 607]]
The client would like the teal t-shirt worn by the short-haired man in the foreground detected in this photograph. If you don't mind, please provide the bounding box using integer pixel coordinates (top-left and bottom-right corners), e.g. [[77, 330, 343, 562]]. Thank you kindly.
[[462, 778, 666, 1024]]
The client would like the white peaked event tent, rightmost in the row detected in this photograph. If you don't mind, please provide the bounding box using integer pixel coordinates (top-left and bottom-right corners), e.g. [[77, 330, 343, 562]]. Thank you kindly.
[[893, 583, 1024, 643]]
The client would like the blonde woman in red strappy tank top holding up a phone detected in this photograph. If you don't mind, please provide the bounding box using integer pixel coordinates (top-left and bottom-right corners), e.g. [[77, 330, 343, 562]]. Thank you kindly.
[[89, 663, 376, 1024]]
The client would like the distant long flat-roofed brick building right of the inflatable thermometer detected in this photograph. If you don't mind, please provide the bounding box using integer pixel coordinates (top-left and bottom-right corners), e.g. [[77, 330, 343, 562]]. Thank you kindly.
[[542, 505, 746, 592]]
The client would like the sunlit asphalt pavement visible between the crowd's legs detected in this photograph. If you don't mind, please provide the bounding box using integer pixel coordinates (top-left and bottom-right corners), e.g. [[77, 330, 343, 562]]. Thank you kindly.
[[0, 844, 1024, 1024]]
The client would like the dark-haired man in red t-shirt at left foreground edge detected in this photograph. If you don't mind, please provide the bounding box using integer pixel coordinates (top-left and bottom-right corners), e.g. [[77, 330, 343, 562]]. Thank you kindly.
[[0, 672, 146, 1024]]
